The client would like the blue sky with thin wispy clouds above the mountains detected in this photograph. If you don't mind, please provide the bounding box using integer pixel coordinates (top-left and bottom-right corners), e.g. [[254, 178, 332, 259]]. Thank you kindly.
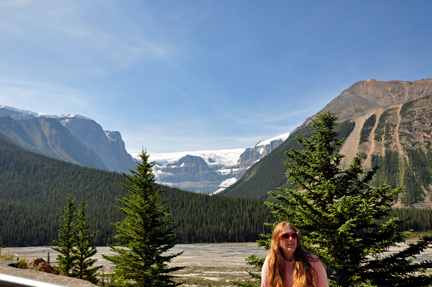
[[0, 0, 432, 154]]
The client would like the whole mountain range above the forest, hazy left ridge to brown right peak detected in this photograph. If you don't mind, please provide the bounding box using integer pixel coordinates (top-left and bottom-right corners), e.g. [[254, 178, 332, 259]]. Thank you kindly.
[[0, 79, 432, 208]]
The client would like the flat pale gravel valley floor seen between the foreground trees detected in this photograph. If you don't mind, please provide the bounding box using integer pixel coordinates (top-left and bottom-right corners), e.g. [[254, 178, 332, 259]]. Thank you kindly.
[[2, 243, 432, 287]]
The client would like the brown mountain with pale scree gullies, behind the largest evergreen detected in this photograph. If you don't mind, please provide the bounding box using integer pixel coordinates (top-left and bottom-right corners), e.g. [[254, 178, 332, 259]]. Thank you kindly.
[[224, 79, 432, 208]]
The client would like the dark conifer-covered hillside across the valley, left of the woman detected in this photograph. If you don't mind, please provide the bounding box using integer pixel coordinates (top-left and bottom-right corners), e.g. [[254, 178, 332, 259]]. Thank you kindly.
[[0, 134, 274, 246]]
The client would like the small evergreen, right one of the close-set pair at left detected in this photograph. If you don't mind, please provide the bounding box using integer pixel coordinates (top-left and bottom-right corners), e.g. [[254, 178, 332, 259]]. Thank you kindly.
[[72, 198, 102, 284]]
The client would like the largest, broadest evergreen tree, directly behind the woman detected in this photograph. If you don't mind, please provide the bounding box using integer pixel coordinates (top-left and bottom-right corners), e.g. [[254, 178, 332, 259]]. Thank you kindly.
[[237, 113, 432, 287]]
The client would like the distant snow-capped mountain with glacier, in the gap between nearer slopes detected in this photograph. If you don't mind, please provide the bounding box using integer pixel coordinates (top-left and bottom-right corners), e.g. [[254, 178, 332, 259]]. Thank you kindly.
[[150, 133, 289, 194]]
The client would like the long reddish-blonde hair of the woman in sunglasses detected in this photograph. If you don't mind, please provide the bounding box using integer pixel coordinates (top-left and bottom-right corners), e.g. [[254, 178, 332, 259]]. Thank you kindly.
[[268, 221, 319, 287]]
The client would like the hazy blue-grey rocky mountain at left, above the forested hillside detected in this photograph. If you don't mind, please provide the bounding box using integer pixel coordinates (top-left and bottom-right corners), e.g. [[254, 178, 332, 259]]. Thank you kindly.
[[0, 106, 136, 172]]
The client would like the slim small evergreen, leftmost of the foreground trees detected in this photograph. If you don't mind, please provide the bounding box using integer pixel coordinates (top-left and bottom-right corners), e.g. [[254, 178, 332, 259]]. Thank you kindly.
[[52, 195, 76, 276]]
